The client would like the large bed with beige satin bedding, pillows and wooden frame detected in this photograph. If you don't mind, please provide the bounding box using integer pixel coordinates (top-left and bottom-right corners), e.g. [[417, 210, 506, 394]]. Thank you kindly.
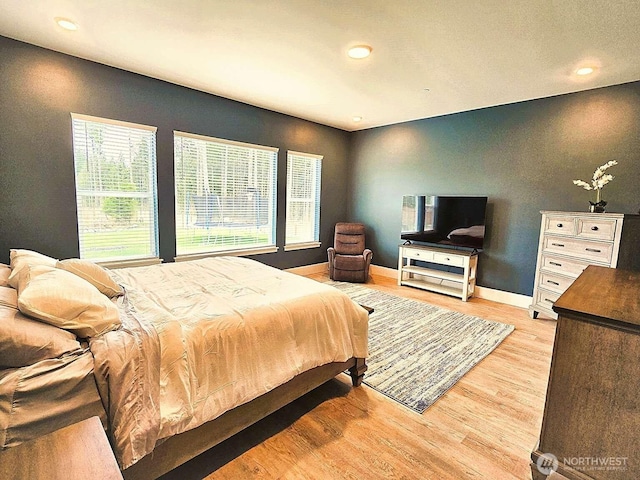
[[0, 250, 368, 478]]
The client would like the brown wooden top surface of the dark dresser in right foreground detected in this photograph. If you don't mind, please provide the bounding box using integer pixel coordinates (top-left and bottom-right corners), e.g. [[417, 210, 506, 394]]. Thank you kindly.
[[553, 265, 640, 332]]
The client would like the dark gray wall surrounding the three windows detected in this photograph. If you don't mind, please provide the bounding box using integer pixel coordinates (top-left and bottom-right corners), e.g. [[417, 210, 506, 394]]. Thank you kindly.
[[0, 37, 349, 268]]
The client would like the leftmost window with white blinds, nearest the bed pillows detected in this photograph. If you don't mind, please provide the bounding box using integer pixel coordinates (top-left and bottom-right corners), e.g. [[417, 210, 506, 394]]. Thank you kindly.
[[71, 113, 158, 262]]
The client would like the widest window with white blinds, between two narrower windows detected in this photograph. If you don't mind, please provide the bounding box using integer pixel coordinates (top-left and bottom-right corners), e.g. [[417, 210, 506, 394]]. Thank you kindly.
[[174, 132, 278, 257]]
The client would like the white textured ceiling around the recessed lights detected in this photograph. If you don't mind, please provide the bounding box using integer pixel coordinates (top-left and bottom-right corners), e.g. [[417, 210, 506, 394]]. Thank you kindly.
[[0, 0, 640, 131]]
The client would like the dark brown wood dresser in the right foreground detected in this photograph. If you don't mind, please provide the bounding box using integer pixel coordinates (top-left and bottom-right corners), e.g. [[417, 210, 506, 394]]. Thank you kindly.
[[531, 265, 640, 480]]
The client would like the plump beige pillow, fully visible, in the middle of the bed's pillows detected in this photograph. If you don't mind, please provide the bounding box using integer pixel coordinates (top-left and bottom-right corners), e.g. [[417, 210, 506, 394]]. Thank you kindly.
[[18, 265, 120, 338]]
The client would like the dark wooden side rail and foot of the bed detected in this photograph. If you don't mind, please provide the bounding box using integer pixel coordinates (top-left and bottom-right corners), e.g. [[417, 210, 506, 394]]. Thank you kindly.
[[122, 358, 367, 480]]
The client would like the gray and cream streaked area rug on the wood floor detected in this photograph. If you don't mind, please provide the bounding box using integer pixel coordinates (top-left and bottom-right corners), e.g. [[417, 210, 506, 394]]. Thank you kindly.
[[328, 281, 515, 413]]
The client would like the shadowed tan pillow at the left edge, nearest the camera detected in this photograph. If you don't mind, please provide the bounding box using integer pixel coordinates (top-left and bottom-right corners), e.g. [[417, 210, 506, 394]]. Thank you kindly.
[[0, 298, 81, 368]]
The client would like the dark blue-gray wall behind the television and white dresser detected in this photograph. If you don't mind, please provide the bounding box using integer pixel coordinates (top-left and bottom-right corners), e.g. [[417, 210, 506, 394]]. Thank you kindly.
[[349, 82, 640, 295]]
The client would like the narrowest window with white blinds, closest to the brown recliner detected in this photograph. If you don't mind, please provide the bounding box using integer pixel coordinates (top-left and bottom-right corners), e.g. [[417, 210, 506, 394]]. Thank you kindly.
[[285, 151, 322, 250]]
